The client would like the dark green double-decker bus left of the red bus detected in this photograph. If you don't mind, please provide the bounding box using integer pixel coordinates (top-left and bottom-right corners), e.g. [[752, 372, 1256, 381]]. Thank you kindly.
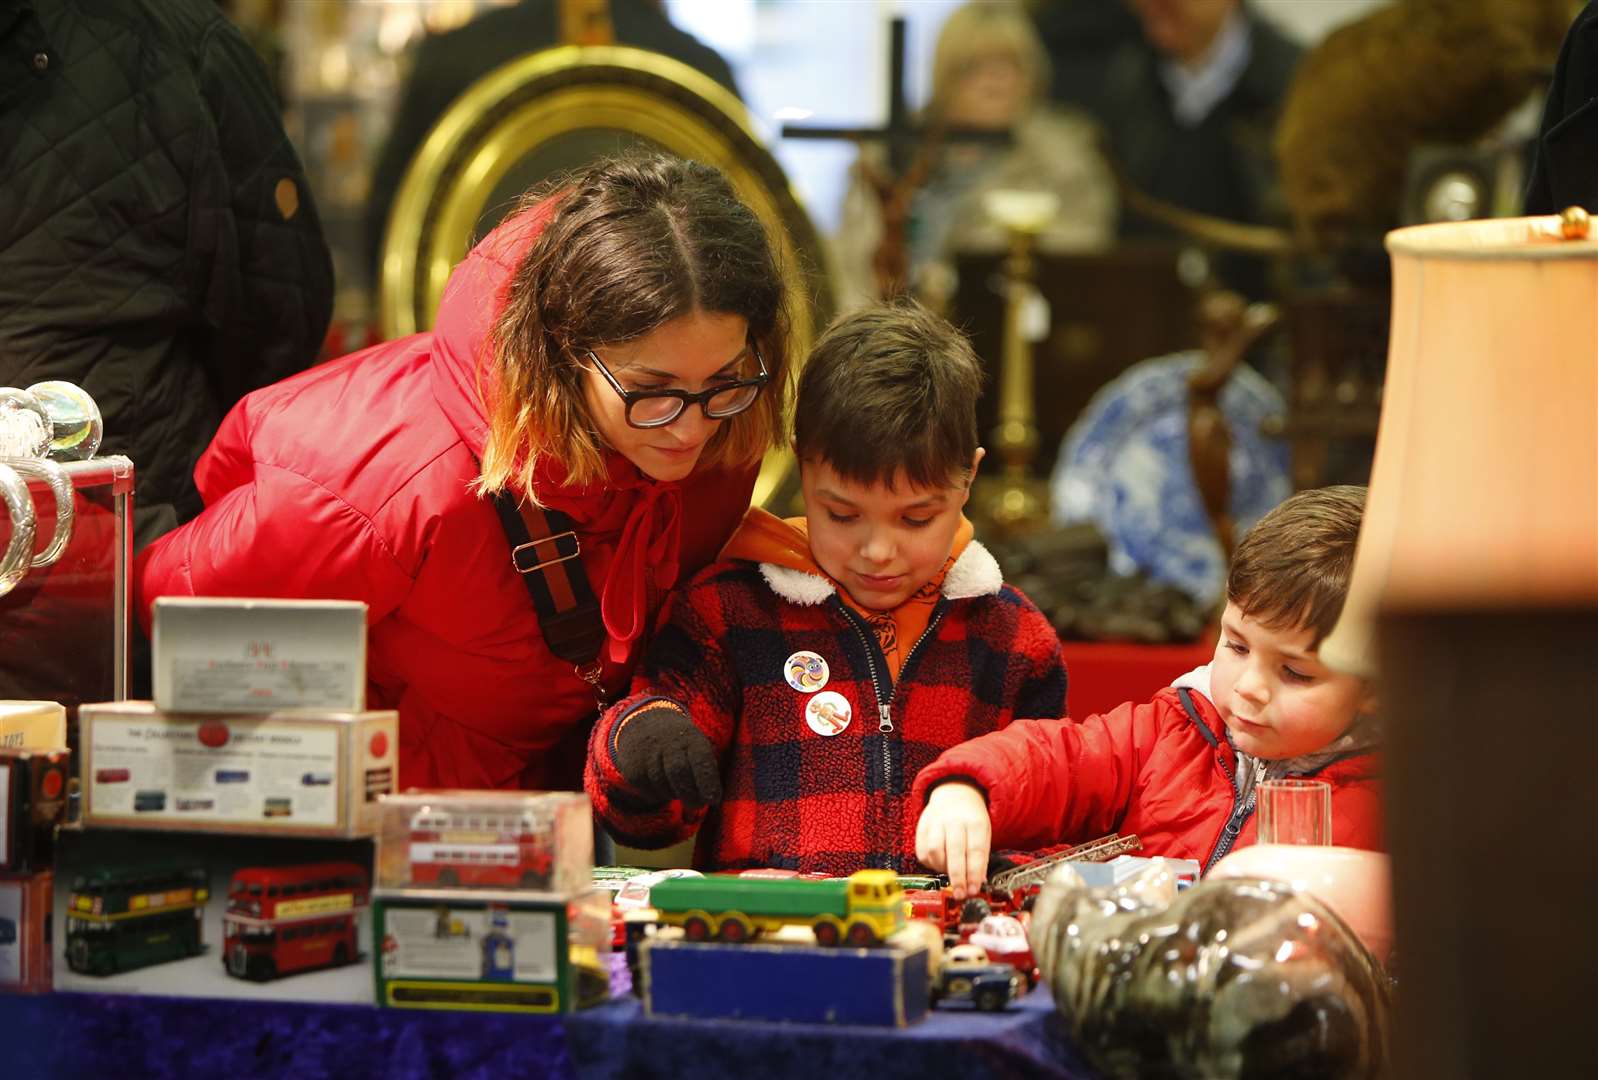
[[66, 866, 211, 975]]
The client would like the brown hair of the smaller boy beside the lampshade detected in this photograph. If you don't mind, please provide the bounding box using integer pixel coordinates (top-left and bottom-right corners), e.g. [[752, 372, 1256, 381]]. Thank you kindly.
[[1226, 484, 1365, 649]]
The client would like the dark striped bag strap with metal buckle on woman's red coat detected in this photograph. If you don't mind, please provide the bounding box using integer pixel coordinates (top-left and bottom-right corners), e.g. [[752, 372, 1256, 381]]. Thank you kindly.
[[494, 490, 604, 690]]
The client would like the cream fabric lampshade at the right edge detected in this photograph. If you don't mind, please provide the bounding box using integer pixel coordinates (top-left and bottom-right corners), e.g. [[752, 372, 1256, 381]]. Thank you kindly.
[[1320, 216, 1598, 676]]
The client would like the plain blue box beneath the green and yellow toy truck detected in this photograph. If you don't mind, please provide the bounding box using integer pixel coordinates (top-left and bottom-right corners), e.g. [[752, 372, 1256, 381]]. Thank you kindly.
[[639, 938, 928, 1027]]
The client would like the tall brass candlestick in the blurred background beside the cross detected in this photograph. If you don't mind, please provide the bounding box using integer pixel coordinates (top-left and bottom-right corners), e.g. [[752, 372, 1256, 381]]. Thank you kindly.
[[984, 190, 1059, 534]]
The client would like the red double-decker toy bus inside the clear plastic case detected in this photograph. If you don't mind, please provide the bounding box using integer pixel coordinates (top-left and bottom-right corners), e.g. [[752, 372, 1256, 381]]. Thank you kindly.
[[411, 805, 555, 888]]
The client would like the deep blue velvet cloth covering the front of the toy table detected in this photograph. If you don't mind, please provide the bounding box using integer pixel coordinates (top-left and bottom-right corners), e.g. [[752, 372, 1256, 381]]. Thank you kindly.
[[0, 989, 1091, 1080]]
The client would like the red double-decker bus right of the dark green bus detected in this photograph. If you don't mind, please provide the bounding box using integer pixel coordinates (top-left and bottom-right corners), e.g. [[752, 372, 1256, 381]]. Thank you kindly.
[[222, 863, 371, 981]]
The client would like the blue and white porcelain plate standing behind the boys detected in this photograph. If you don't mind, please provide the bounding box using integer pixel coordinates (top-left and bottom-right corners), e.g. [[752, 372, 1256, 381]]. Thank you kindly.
[[1050, 351, 1293, 604]]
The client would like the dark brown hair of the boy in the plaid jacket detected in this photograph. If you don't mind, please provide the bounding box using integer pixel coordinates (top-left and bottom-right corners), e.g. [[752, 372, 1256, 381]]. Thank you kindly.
[[794, 300, 983, 487]]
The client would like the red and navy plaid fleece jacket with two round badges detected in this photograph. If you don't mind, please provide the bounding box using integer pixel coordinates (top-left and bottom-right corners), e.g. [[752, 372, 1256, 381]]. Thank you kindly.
[[586, 543, 1066, 874]]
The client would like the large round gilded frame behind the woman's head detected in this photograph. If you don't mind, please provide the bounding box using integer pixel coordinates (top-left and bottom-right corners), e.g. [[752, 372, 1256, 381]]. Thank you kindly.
[[380, 46, 833, 503]]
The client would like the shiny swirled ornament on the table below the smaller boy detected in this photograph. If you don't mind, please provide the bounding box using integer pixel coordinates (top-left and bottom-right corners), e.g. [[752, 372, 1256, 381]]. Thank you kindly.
[[1031, 861, 1390, 1078]]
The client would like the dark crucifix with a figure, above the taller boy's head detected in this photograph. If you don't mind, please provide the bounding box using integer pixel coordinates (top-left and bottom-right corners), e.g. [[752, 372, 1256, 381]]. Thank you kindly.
[[783, 16, 1010, 299]]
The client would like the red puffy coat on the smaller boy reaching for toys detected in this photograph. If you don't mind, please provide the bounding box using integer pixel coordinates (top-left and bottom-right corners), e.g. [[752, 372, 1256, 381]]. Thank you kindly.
[[916, 687, 1382, 869]]
